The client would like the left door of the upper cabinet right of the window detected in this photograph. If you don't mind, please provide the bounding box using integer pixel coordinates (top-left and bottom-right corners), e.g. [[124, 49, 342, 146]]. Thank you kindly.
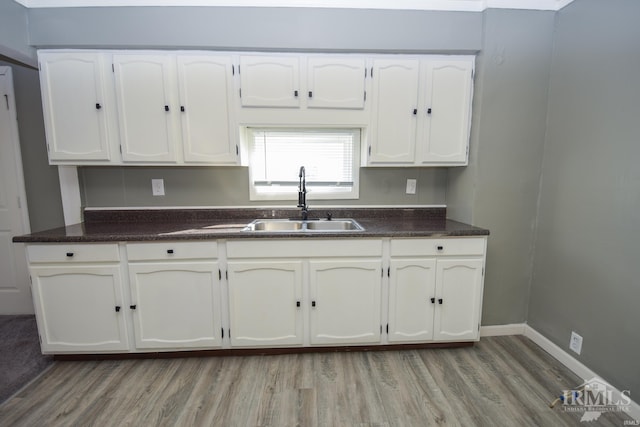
[[367, 59, 419, 165]]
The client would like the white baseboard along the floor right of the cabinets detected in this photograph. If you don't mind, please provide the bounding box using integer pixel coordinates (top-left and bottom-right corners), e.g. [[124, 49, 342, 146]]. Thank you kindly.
[[480, 323, 640, 422]]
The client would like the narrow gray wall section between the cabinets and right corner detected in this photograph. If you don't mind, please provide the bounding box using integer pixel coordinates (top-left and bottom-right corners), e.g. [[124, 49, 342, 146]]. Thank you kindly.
[[447, 9, 554, 325]]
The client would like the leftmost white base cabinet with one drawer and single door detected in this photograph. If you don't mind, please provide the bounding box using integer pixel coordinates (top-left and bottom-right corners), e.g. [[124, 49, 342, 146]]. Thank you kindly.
[[27, 244, 129, 353]]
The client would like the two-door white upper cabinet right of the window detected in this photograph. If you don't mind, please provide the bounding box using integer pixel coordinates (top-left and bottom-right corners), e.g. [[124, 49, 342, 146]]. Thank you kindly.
[[363, 56, 474, 166]]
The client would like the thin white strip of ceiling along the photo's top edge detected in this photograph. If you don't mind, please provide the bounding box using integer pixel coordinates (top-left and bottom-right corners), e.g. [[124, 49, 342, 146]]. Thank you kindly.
[[15, 0, 573, 12]]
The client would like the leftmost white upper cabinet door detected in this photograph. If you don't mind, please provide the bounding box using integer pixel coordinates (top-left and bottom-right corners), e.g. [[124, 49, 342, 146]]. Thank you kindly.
[[39, 53, 117, 163]]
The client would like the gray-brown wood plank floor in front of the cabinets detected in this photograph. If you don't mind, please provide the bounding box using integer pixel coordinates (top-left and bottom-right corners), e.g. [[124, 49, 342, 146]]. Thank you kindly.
[[0, 336, 624, 427]]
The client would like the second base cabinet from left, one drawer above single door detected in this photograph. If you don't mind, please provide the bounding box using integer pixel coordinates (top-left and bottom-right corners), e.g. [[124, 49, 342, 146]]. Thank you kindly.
[[127, 242, 222, 350]]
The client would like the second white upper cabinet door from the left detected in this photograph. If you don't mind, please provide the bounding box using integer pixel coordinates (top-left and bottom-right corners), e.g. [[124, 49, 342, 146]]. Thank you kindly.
[[113, 55, 177, 163]]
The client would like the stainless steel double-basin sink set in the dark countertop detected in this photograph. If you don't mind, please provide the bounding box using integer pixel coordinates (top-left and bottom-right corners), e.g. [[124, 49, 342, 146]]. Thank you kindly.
[[242, 219, 364, 233]]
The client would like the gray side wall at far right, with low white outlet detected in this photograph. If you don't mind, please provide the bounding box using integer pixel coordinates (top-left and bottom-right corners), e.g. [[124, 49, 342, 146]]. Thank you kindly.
[[528, 0, 640, 402]]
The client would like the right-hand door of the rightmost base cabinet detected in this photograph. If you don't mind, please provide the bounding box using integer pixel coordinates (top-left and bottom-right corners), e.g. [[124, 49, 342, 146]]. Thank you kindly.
[[434, 259, 483, 341]]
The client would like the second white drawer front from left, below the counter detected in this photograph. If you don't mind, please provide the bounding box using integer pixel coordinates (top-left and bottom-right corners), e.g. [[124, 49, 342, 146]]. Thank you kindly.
[[127, 241, 218, 261]]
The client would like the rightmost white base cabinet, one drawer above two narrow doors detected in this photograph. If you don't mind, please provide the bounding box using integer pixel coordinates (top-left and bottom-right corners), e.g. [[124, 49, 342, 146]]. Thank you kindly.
[[388, 238, 486, 343]]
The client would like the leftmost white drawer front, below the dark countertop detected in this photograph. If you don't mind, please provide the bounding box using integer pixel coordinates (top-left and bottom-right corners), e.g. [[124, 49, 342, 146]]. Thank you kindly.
[[27, 243, 120, 263]]
